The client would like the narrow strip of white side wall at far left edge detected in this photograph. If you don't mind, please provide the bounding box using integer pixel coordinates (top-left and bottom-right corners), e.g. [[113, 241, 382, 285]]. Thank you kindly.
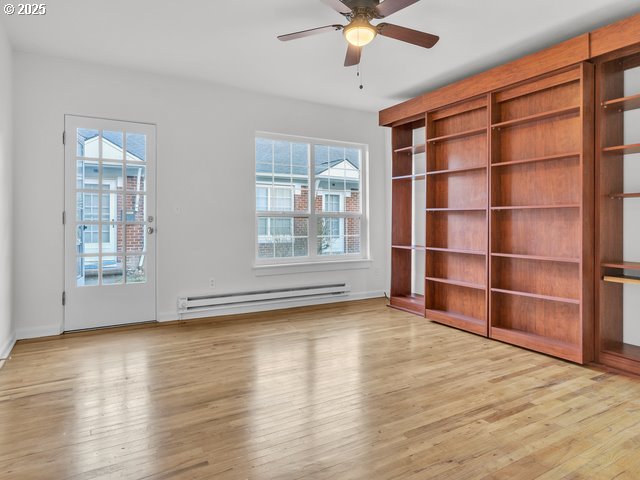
[[0, 22, 15, 358]]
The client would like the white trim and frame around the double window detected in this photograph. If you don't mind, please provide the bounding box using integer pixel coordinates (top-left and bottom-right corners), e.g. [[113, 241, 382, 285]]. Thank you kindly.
[[253, 131, 370, 269]]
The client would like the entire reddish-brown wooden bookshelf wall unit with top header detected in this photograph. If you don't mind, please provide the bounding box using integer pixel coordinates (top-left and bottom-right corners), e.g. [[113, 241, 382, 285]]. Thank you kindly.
[[379, 11, 640, 374]]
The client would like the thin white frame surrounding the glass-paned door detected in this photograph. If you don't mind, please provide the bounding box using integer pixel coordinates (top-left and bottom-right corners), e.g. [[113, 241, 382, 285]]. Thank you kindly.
[[60, 113, 159, 333]]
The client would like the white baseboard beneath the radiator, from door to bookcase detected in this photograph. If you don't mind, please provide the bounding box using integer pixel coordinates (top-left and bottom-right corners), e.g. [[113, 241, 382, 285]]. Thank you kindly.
[[158, 290, 384, 322]]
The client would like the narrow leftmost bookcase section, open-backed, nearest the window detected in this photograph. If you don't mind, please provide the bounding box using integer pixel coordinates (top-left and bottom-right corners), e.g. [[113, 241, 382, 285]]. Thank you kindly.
[[391, 120, 426, 315]]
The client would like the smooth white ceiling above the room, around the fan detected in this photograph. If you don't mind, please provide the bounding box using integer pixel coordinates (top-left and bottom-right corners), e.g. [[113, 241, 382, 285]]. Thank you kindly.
[[0, 0, 640, 111]]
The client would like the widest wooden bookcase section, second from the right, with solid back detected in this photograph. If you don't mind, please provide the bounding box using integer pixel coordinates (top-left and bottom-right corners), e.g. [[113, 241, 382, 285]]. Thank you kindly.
[[489, 64, 593, 363]]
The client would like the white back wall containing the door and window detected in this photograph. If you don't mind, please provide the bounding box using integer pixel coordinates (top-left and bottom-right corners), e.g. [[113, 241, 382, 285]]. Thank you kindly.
[[14, 52, 388, 338]]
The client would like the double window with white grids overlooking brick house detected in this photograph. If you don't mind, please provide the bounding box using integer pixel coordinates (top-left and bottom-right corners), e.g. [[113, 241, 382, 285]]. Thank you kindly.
[[255, 134, 367, 264]]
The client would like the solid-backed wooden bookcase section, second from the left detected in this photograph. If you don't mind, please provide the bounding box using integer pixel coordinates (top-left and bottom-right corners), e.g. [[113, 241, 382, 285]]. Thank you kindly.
[[425, 95, 488, 336]]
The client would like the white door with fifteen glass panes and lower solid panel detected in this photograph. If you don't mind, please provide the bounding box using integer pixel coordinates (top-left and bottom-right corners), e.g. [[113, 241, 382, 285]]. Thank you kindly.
[[64, 115, 156, 331]]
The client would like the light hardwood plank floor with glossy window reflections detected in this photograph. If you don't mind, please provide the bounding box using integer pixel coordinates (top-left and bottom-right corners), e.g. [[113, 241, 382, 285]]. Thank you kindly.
[[0, 300, 640, 480]]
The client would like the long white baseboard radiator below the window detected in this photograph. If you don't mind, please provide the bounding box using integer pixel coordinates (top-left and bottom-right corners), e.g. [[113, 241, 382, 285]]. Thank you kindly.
[[178, 283, 351, 313]]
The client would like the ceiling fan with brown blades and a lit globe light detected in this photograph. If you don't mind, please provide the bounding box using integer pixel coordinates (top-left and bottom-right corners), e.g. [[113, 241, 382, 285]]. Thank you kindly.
[[278, 0, 440, 67]]
